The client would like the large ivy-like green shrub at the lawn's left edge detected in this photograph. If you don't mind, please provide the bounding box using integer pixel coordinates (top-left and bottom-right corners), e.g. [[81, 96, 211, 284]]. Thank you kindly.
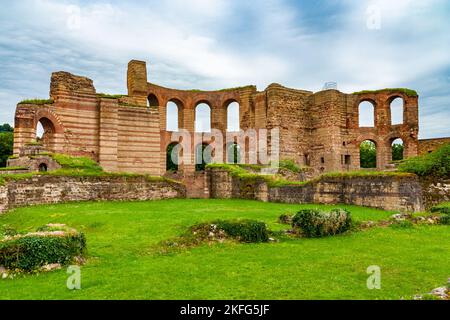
[[0, 229, 86, 272]]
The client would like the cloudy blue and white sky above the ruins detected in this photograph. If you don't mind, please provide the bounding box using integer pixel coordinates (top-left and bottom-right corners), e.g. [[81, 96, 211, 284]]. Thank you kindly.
[[0, 0, 450, 138]]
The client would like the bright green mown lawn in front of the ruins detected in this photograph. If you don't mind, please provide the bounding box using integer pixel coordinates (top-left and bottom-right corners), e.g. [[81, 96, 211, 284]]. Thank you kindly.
[[0, 200, 450, 299]]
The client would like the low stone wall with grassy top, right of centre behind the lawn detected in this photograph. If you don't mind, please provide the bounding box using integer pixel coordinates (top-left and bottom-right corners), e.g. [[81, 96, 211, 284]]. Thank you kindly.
[[209, 168, 424, 212]]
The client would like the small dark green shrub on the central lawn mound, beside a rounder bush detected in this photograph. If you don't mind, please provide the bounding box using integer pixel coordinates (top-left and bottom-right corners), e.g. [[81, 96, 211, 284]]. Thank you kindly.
[[215, 220, 269, 242]]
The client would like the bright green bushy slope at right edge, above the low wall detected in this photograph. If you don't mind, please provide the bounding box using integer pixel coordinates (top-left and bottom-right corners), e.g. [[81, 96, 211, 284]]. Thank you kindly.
[[398, 143, 450, 178]]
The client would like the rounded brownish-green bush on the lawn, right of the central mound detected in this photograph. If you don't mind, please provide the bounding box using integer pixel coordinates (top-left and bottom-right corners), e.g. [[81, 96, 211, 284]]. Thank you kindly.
[[292, 209, 352, 238]]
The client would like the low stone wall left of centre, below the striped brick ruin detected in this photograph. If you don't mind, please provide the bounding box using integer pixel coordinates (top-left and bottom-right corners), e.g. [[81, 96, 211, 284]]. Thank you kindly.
[[0, 175, 186, 213]]
